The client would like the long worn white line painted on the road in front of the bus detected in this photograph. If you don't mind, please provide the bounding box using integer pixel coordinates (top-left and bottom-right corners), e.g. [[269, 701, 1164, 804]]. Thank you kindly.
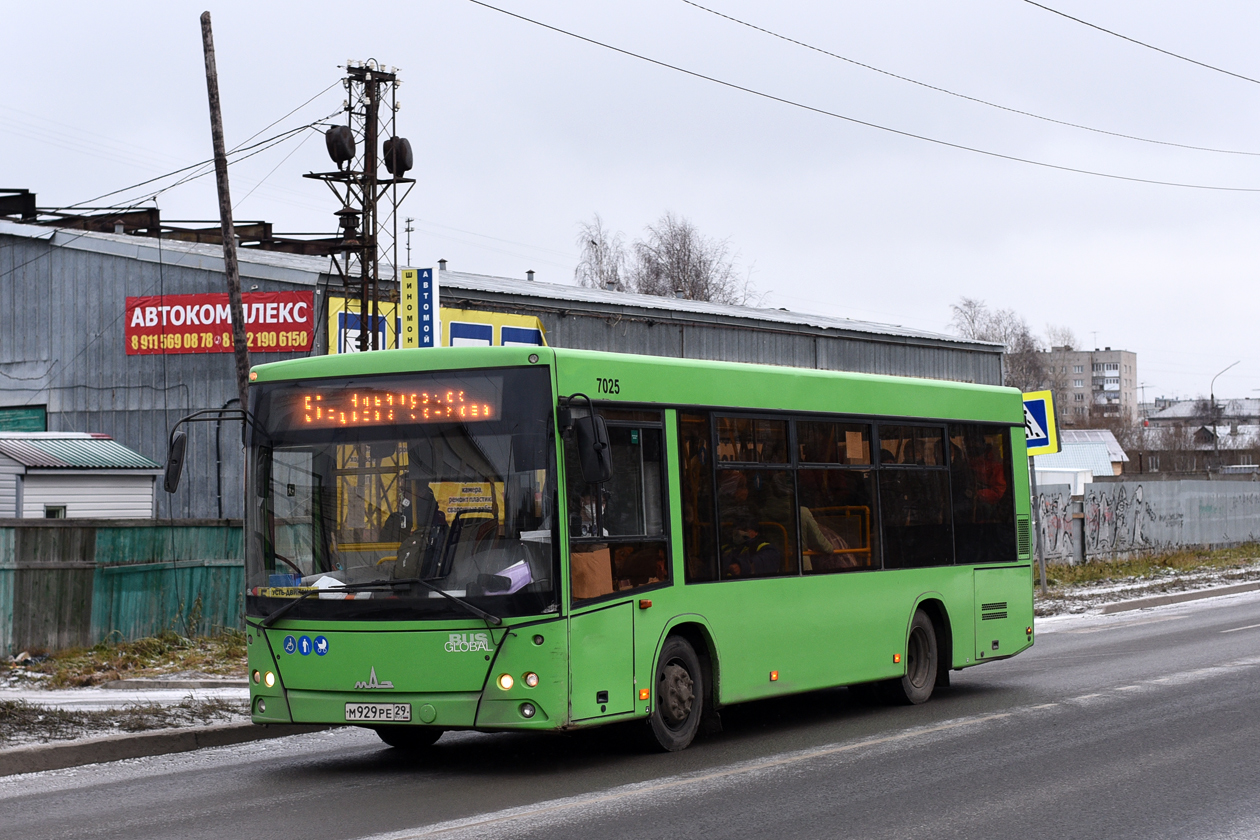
[[359, 713, 1013, 840]]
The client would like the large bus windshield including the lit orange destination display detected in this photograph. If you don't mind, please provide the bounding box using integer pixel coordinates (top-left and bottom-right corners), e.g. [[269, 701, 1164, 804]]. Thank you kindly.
[[246, 368, 559, 620]]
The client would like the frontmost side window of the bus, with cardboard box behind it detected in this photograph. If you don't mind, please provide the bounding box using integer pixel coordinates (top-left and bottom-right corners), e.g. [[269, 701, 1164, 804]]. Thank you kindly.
[[564, 412, 669, 601]]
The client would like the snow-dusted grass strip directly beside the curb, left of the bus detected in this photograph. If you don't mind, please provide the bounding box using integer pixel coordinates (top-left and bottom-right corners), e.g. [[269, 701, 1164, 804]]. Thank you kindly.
[[0, 698, 246, 746]]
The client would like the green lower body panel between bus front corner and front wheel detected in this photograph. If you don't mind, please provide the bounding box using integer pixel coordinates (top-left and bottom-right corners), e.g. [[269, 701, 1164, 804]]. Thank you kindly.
[[568, 602, 635, 722]]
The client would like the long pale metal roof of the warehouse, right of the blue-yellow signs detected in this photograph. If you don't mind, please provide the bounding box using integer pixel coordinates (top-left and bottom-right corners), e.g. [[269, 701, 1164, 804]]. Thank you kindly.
[[438, 271, 1002, 353]]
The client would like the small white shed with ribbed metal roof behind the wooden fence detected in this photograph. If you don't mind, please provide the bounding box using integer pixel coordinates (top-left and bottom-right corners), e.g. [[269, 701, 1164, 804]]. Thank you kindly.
[[0, 432, 163, 519]]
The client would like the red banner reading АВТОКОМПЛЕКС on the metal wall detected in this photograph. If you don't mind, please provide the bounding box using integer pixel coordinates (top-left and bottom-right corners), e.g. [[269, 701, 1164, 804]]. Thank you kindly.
[[123, 292, 315, 355]]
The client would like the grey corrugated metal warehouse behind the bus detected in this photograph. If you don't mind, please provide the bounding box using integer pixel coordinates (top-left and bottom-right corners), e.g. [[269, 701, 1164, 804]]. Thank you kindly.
[[0, 220, 1002, 518]]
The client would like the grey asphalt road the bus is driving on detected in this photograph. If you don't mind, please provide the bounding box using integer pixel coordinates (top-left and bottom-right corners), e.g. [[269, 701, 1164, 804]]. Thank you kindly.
[[0, 593, 1260, 840]]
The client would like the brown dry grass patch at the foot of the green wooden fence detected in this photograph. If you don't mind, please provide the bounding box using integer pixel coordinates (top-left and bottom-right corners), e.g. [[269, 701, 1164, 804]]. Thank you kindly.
[[10, 631, 246, 688]]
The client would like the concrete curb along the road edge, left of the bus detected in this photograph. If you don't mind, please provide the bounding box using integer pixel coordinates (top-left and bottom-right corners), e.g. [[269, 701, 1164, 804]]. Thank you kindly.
[[0, 723, 331, 776]]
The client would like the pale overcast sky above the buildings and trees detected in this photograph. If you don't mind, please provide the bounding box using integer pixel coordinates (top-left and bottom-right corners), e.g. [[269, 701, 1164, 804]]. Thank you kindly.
[[0, 0, 1260, 399]]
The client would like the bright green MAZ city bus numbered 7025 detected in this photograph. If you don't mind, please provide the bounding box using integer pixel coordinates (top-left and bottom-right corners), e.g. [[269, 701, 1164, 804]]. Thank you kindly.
[[226, 346, 1033, 751]]
